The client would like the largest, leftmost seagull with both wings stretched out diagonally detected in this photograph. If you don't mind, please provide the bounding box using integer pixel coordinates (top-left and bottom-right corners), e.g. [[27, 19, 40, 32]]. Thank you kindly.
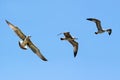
[[6, 20, 47, 61]]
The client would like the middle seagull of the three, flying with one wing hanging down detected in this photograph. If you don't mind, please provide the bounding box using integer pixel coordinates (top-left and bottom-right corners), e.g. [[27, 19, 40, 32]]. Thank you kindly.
[[60, 32, 78, 57]]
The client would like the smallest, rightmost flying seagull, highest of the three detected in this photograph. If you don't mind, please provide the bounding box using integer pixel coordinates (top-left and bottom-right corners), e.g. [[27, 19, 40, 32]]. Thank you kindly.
[[87, 18, 112, 35]]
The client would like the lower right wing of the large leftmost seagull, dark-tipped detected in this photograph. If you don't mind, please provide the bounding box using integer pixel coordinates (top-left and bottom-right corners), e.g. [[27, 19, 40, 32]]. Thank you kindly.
[[28, 41, 47, 61]]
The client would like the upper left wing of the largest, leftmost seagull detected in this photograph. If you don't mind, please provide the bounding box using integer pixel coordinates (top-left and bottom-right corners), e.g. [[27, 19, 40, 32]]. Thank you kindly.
[[6, 20, 26, 40]]
